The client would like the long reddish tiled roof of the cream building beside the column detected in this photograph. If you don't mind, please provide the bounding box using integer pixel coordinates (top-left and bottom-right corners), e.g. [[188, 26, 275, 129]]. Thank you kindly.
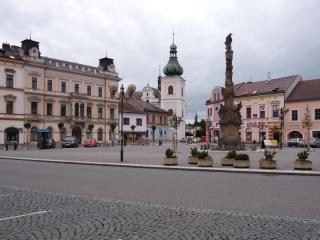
[[234, 75, 298, 97]]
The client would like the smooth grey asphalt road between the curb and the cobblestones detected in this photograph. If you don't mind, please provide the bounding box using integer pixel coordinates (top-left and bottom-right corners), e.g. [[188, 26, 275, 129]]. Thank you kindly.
[[0, 159, 320, 220]]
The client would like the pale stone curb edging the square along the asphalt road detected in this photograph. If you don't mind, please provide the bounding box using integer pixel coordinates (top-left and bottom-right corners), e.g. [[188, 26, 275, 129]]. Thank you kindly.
[[0, 156, 320, 176]]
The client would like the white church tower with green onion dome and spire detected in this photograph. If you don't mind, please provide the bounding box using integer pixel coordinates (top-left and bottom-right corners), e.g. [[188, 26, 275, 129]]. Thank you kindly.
[[161, 34, 186, 140]]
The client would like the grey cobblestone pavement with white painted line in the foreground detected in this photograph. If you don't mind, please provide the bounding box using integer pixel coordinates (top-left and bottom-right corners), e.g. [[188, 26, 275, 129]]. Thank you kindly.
[[0, 186, 320, 240]]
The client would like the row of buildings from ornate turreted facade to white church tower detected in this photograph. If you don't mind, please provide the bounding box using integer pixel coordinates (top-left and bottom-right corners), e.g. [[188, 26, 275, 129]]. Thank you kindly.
[[0, 36, 186, 144]]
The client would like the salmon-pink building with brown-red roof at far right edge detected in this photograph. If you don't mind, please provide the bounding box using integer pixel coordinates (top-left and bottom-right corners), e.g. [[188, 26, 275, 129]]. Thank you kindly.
[[284, 79, 320, 142]]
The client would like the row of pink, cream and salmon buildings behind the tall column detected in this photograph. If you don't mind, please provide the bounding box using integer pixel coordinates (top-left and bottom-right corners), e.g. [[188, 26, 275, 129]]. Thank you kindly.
[[206, 75, 320, 142]]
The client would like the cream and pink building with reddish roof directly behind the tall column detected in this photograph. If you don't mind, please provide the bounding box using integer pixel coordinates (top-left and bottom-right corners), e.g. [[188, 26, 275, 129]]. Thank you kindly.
[[206, 75, 302, 142]]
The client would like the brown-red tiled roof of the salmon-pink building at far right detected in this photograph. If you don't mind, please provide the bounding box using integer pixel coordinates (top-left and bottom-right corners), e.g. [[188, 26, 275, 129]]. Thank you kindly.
[[287, 79, 320, 102]]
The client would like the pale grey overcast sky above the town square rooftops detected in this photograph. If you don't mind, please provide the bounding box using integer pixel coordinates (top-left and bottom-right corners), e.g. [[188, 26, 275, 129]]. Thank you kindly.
[[0, 0, 320, 122]]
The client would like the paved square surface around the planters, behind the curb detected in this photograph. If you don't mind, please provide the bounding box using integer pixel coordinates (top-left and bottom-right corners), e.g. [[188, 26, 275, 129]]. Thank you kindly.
[[0, 144, 320, 173]]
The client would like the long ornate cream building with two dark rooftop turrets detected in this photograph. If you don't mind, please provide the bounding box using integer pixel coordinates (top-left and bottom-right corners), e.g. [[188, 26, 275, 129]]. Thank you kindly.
[[0, 39, 120, 143]]
